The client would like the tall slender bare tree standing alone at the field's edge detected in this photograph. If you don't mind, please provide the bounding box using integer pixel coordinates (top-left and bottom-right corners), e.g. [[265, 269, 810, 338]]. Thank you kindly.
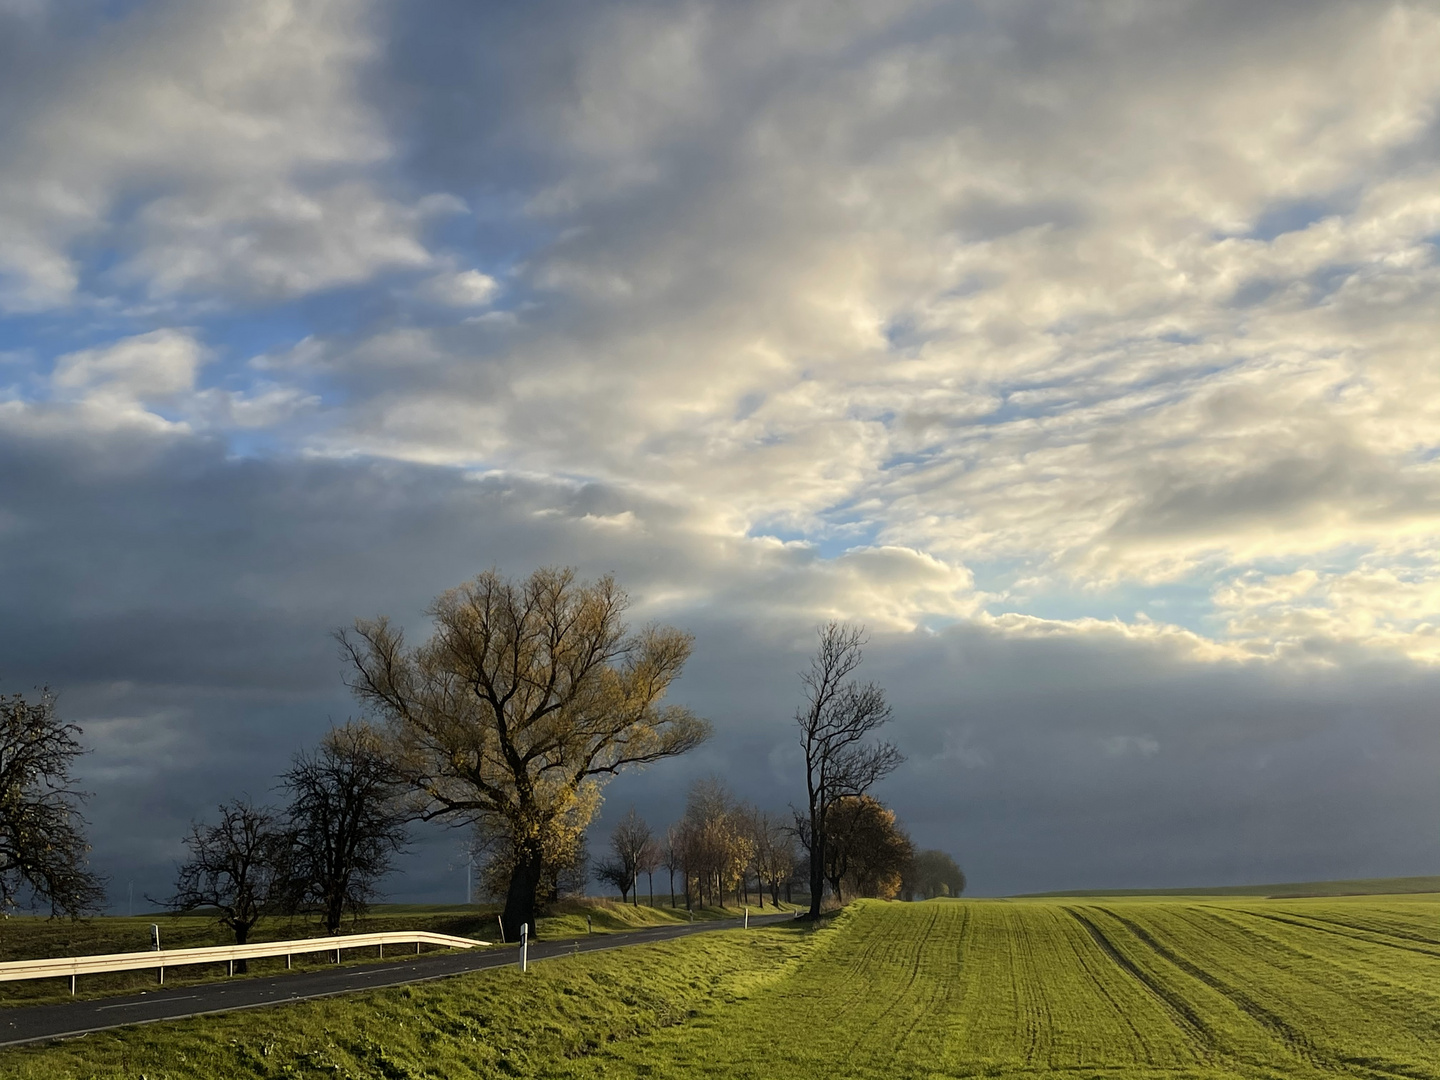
[[795, 622, 904, 919]]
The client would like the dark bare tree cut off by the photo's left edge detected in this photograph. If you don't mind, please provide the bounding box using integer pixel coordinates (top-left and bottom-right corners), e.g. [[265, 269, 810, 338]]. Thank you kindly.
[[0, 690, 105, 919]]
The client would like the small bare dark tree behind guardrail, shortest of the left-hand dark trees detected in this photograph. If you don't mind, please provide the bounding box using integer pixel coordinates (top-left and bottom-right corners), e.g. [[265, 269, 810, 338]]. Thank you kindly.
[[163, 798, 288, 972]]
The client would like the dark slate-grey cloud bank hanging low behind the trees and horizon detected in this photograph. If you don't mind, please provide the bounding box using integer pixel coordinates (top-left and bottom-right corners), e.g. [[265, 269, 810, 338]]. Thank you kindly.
[[0, 417, 1440, 900]]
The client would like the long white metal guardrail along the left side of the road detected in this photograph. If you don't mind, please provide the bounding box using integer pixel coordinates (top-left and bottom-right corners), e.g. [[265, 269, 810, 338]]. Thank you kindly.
[[0, 930, 490, 994]]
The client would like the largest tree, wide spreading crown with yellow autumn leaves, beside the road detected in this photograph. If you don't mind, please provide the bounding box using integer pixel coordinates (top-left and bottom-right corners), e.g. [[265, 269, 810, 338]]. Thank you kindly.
[[338, 569, 710, 936]]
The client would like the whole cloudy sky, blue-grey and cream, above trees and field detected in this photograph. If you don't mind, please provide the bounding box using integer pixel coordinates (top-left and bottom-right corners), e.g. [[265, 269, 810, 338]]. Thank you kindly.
[[0, 0, 1440, 910]]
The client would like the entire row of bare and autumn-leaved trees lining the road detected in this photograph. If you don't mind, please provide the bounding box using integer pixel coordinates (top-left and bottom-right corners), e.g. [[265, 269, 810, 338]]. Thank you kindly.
[[0, 569, 967, 939]]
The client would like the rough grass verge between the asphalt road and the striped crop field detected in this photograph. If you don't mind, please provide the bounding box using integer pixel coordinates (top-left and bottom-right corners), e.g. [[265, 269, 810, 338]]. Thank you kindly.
[[0, 926, 825, 1080]]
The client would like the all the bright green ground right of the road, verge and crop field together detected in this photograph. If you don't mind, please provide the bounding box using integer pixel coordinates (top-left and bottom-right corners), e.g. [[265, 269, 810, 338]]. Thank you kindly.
[[0, 896, 1440, 1080]]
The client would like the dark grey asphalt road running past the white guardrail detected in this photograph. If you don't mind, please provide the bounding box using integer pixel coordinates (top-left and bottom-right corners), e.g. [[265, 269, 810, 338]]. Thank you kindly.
[[0, 914, 793, 1045]]
